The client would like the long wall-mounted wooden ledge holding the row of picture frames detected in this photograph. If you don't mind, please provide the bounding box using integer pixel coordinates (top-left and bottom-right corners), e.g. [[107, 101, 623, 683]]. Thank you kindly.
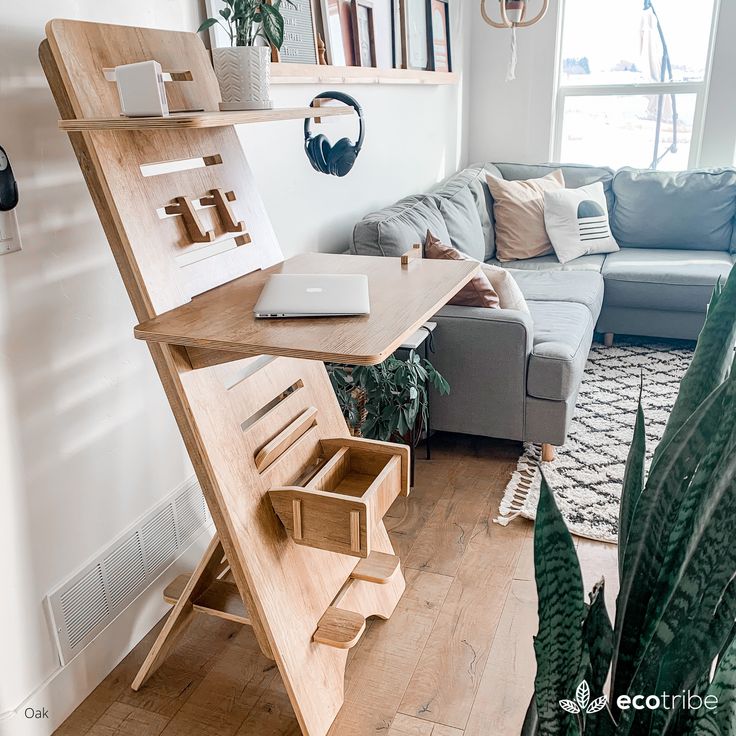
[[271, 63, 458, 85]]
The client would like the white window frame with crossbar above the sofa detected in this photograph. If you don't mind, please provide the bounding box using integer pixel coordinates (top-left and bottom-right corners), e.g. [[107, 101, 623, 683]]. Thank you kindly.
[[550, 0, 721, 169]]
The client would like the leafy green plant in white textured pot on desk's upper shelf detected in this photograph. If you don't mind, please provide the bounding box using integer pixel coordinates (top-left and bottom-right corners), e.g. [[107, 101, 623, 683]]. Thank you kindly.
[[198, 0, 291, 110]]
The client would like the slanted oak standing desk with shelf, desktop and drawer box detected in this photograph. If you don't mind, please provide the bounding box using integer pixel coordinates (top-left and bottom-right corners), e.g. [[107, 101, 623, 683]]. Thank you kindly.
[[40, 20, 479, 736]]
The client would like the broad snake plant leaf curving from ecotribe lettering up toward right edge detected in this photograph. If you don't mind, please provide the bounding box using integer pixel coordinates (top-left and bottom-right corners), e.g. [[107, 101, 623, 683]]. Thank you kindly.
[[612, 384, 726, 704]]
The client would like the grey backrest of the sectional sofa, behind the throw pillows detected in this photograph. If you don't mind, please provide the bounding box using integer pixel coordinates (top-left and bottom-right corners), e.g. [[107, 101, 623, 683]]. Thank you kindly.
[[353, 162, 736, 261]]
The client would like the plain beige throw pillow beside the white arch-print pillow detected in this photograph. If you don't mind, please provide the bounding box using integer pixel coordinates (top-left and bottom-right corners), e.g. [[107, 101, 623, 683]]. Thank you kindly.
[[486, 169, 565, 261]]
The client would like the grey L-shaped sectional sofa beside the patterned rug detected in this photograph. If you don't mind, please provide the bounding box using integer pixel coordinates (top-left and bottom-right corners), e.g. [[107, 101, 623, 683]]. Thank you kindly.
[[353, 163, 736, 445]]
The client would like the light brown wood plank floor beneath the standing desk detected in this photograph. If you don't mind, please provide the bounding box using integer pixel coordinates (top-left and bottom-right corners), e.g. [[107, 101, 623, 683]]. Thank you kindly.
[[56, 435, 617, 736]]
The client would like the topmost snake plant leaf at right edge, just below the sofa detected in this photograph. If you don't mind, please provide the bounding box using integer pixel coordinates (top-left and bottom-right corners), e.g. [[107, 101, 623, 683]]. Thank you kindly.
[[652, 269, 736, 465]]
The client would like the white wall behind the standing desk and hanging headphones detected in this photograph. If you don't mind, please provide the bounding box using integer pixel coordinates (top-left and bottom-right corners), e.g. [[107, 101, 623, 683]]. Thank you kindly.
[[0, 0, 474, 734]]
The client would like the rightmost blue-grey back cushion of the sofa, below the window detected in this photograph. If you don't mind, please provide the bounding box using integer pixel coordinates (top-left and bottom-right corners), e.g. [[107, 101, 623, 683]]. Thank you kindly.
[[611, 169, 736, 251]]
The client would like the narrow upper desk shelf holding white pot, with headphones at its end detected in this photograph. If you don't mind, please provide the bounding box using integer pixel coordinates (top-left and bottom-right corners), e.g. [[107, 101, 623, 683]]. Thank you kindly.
[[59, 105, 353, 133]]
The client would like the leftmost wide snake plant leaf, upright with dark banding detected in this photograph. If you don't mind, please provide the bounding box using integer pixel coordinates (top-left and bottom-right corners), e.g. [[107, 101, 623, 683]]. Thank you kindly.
[[534, 476, 585, 736]]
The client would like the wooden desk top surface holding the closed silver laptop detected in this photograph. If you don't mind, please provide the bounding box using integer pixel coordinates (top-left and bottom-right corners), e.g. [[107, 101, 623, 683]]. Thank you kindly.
[[135, 253, 480, 365]]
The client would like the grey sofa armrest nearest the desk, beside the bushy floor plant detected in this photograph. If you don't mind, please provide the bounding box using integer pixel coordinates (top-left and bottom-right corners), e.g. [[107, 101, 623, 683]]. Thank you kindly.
[[431, 306, 534, 439]]
